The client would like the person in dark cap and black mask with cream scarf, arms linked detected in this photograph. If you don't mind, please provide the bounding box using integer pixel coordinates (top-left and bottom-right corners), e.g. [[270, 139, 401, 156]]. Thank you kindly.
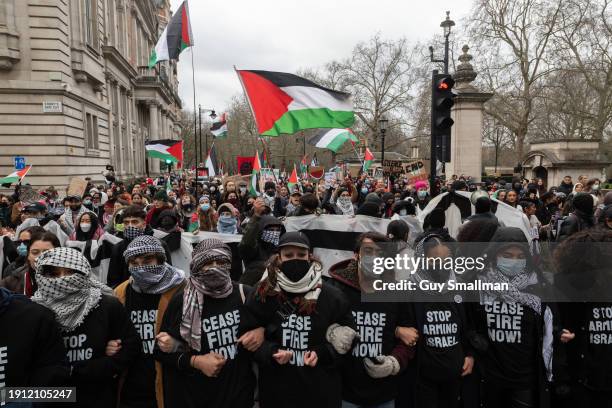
[[240, 232, 356, 407]]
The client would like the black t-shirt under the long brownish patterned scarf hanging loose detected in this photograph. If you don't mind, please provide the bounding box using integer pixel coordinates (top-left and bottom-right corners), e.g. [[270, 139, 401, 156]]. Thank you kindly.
[[156, 284, 255, 408]]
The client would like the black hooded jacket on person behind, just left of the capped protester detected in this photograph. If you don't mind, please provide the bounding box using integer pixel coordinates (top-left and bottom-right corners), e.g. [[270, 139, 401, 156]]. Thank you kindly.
[[238, 215, 285, 286]]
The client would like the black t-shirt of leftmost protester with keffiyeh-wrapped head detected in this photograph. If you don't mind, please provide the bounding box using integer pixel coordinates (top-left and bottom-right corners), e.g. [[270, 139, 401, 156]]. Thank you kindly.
[[64, 295, 142, 408]]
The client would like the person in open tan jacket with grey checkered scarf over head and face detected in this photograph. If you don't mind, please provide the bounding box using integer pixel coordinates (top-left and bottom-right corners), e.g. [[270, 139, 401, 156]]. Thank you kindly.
[[115, 235, 185, 407]]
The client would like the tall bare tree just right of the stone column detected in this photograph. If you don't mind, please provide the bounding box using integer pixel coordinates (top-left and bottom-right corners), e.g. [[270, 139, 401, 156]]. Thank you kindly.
[[469, 0, 563, 160]]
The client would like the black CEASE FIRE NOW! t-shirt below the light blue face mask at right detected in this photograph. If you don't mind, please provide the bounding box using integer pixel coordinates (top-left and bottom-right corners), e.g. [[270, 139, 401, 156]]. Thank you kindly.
[[480, 300, 540, 388]]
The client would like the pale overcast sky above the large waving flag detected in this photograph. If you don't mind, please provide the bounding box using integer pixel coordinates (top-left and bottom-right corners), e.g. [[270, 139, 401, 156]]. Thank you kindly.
[[171, 0, 472, 115]]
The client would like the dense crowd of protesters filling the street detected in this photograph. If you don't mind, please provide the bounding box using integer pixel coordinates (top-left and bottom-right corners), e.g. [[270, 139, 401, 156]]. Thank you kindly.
[[0, 168, 612, 408]]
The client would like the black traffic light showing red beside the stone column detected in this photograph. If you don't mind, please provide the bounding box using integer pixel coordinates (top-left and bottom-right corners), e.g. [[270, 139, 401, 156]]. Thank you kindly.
[[431, 74, 455, 162]]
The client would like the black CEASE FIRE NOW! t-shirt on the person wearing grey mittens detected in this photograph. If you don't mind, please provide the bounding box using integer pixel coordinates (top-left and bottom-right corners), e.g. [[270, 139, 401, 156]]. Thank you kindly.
[[331, 280, 409, 405]]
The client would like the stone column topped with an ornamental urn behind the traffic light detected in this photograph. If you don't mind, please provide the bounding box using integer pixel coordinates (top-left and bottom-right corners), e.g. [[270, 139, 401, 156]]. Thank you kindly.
[[446, 45, 493, 182]]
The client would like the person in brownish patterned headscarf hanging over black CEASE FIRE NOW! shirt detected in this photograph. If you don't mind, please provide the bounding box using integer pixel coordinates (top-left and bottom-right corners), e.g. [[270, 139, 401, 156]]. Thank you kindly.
[[155, 239, 263, 408]]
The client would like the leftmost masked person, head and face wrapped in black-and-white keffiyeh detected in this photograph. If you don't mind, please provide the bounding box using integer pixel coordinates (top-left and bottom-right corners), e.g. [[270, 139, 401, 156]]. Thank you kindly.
[[32, 248, 140, 408]]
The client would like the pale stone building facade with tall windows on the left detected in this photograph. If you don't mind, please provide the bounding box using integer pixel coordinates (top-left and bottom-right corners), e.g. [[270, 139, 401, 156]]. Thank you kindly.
[[0, 0, 181, 187]]
